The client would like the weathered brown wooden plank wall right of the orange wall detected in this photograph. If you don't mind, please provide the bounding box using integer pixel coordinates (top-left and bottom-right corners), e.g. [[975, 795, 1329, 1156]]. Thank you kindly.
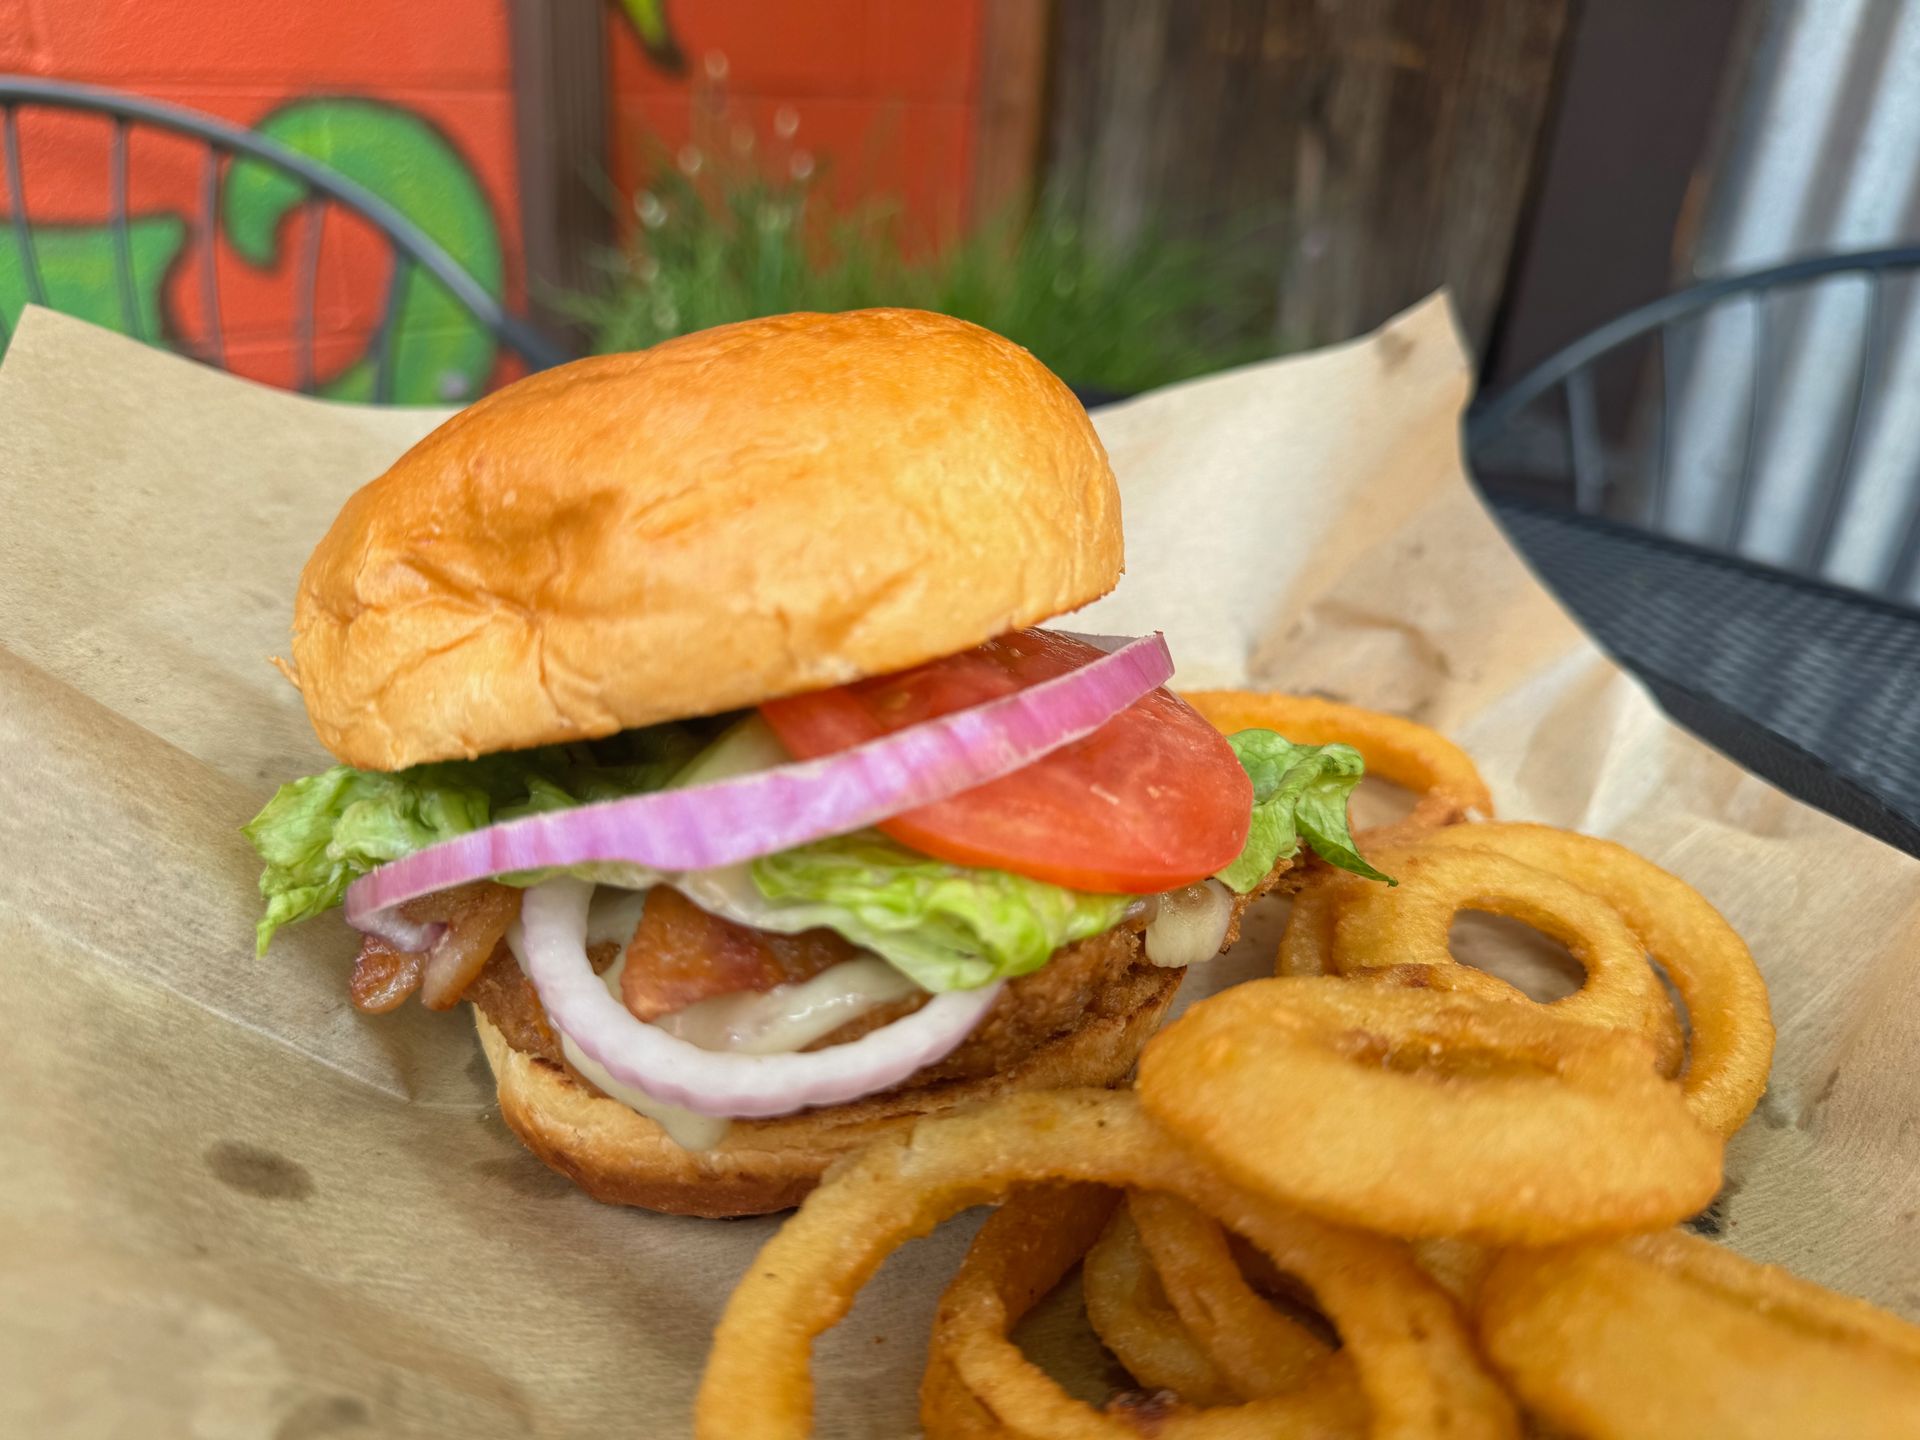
[[1048, 0, 1569, 346]]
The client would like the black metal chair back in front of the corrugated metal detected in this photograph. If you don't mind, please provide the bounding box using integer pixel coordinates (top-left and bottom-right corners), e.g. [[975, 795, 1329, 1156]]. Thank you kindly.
[[1467, 246, 1920, 599]]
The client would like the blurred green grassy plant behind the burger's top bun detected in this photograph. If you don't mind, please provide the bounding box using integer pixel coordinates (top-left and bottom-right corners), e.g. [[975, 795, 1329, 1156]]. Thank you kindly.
[[564, 96, 1277, 394]]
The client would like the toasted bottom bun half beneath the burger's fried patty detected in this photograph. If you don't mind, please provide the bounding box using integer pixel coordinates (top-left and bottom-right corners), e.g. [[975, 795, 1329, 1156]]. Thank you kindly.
[[474, 968, 1187, 1219]]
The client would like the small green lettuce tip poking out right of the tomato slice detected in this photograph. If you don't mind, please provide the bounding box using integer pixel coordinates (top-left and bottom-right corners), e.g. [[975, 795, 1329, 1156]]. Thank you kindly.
[[1219, 730, 1392, 895]]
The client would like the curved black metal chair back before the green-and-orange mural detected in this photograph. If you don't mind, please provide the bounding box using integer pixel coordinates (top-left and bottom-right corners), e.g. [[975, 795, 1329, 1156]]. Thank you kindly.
[[0, 77, 570, 403]]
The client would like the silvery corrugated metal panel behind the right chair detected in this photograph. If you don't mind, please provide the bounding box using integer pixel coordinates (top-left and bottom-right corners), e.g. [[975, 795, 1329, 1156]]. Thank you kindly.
[[1674, 0, 1920, 601]]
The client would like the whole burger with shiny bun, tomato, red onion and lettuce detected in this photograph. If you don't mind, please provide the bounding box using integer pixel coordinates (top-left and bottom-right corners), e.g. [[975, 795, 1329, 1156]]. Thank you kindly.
[[246, 309, 1367, 1215]]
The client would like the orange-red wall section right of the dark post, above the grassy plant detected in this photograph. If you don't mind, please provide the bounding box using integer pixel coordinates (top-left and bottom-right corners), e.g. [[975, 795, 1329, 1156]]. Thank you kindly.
[[611, 0, 981, 238]]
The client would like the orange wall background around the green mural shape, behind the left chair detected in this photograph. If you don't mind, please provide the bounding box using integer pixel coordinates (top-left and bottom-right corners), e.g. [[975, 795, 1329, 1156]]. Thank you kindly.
[[0, 0, 520, 395]]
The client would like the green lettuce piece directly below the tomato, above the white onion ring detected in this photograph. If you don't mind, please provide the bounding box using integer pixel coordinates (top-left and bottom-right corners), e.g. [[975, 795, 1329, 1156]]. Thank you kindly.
[[753, 831, 1133, 991]]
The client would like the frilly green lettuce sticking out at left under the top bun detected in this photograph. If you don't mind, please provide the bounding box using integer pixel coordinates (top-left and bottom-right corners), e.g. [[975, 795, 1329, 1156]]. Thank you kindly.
[[244, 726, 705, 954]]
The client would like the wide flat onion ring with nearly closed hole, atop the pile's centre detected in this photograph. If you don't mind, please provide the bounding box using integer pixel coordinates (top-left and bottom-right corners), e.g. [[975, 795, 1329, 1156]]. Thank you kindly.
[[1137, 977, 1720, 1244]]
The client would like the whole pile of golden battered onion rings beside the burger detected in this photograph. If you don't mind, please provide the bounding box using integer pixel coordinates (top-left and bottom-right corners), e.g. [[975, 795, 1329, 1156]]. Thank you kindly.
[[697, 691, 1920, 1440]]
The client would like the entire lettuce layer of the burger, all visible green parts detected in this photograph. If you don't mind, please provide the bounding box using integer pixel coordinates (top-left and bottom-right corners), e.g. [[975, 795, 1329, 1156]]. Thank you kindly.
[[246, 720, 1384, 991]]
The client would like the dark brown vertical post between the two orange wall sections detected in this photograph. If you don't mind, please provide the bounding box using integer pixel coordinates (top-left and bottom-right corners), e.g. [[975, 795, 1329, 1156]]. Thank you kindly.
[[509, 0, 612, 348]]
